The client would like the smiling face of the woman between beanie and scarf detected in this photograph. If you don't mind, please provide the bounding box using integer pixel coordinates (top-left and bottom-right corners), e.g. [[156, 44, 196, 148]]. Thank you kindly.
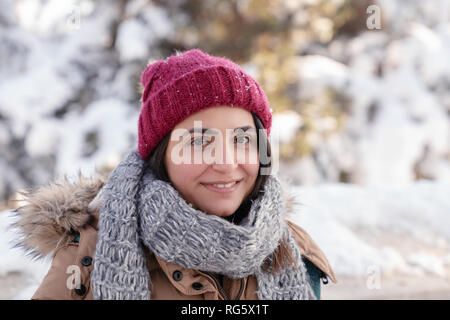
[[164, 106, 259, 217]]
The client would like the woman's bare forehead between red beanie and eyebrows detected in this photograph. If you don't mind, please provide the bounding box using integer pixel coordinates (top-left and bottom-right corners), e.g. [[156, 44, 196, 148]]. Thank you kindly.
[[175, 106, 255, 129]]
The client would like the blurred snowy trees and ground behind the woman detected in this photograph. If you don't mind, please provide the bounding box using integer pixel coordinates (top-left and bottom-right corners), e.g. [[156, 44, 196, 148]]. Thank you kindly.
[[0, 0, 450, 299]]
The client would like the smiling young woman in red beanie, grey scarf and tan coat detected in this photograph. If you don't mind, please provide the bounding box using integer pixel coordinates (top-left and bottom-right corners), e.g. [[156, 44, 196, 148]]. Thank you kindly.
[[12, 49, 336, 299]]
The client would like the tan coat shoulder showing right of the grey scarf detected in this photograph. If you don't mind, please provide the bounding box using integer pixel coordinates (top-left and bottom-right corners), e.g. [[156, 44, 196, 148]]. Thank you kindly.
[[286, 220, 337, 283]]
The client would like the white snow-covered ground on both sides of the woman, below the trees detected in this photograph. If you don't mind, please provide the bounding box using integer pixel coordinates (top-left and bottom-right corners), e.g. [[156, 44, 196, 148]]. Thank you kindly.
[[0, 181, 450, 299]]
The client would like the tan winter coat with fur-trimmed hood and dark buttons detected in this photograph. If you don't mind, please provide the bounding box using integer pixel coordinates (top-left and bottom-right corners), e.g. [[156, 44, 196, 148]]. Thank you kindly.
[[16, 177, 337, 300]]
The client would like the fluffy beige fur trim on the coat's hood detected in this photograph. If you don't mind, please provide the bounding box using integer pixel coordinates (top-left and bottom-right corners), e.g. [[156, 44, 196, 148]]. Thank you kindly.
[[12, 175, 298, 259]]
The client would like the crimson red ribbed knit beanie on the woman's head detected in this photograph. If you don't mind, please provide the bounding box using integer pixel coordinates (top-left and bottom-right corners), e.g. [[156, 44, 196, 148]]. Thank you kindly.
[[138, 49, 272, 159]]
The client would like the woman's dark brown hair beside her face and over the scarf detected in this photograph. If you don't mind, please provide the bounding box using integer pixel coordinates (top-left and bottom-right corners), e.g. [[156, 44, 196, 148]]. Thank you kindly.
[[147, 113, 297, 273]]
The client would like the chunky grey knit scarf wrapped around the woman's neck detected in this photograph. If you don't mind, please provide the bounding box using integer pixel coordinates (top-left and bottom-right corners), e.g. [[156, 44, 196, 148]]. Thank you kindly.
[[91, 151, 315, 300]]
